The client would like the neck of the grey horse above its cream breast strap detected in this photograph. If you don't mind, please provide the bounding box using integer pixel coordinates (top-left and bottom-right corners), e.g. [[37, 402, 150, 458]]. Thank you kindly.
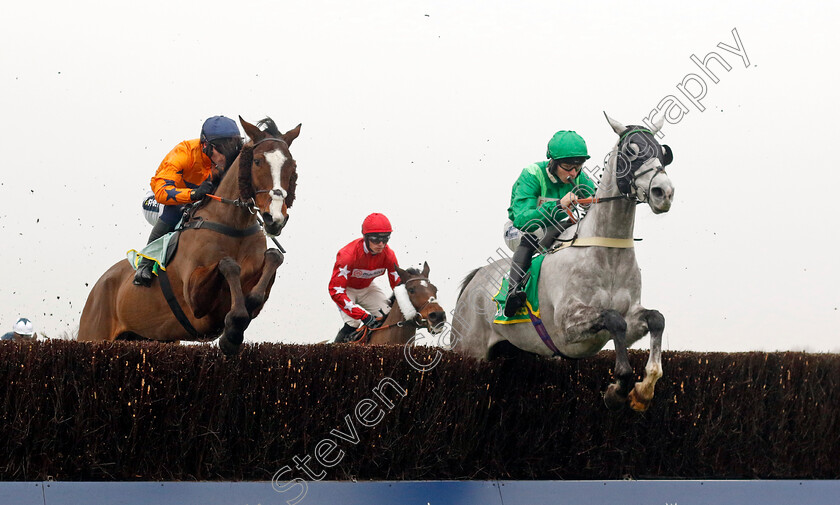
[[578, 147, 636, 238]]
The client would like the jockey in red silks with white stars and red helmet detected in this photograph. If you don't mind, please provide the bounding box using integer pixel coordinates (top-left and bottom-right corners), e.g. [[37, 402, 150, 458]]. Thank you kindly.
[[330, 213, 400, 342]]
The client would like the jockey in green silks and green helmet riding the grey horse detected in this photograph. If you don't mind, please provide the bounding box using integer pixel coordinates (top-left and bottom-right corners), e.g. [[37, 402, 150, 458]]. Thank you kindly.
[[505, 130, 596, 317]]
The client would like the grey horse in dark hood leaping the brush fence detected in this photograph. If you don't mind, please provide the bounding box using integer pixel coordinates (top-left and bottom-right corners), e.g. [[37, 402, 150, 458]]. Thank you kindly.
[[452, 114, 674, 411]]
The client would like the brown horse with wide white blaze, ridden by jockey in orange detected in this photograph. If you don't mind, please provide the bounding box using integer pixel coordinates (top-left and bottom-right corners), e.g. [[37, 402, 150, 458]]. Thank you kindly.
[[78, 116, 301, 355]]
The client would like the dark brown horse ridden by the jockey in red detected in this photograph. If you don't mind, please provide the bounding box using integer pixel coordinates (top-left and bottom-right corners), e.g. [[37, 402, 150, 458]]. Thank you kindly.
[[346, 263, 446, 345]]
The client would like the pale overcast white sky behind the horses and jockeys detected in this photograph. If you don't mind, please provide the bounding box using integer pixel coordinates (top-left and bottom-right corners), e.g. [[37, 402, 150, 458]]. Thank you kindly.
[[0, 0, 840, 351]]
